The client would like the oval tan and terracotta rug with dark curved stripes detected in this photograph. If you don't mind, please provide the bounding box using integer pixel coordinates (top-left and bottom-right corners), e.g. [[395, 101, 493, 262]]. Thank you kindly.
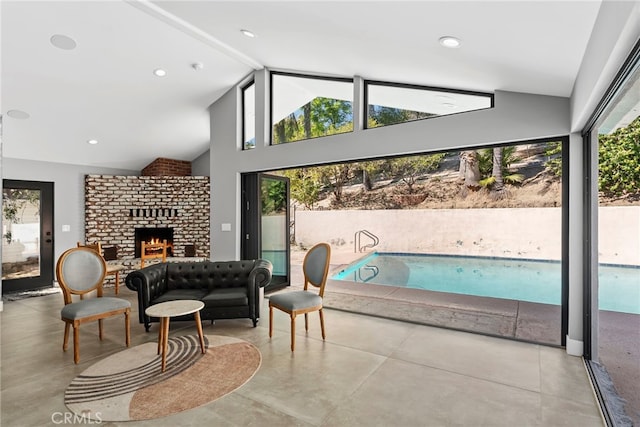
[[65, 335, 262, 421]]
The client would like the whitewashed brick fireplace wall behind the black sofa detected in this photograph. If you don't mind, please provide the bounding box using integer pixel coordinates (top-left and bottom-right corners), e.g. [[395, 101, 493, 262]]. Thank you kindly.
[[85, 175, 211, 259]]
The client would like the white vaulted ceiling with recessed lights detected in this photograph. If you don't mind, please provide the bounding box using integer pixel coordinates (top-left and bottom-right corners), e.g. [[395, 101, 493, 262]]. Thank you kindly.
[[0, 0, 600, 170]]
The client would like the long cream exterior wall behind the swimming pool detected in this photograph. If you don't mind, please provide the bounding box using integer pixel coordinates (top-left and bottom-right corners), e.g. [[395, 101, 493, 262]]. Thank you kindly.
[[294, 206, 640, 266]]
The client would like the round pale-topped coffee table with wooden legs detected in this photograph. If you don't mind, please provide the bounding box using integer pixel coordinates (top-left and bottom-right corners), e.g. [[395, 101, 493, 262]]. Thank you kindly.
[[144, 300, 205, 372]]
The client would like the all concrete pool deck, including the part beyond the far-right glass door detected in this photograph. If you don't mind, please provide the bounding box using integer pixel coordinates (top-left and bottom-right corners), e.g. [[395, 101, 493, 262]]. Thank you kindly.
[[283, 248, 640, 426]]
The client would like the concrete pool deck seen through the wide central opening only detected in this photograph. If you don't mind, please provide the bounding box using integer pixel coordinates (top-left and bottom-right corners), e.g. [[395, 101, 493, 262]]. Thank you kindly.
[[290, 250, 561, 345]]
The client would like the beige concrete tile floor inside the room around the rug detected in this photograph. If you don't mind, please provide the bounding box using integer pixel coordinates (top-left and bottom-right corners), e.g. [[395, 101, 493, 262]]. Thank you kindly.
[[0, 288, 603, 427]]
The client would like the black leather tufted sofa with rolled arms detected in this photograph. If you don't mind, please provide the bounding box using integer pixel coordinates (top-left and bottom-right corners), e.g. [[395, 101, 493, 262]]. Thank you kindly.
[[125, 259, 273, 332]]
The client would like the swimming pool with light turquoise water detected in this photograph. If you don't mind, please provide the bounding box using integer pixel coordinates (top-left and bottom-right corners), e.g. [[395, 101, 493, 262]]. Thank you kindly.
[[332, 252, 640, 314]]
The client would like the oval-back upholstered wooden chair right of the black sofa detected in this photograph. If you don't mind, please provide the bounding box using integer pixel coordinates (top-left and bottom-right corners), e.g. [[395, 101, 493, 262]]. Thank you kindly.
[[269, 243, 331, 351]]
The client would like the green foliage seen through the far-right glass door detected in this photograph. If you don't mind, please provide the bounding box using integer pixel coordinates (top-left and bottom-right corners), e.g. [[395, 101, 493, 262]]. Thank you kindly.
[[598, 117, 640, 196]]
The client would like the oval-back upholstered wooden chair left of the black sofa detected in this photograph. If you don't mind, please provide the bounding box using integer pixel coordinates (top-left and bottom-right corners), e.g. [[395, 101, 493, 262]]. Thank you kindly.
[[56, 247, 131, 364]]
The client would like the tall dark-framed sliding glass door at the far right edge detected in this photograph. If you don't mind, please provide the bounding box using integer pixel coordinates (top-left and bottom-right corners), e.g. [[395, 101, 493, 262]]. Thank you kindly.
[[584, 44, 640, 425]]
